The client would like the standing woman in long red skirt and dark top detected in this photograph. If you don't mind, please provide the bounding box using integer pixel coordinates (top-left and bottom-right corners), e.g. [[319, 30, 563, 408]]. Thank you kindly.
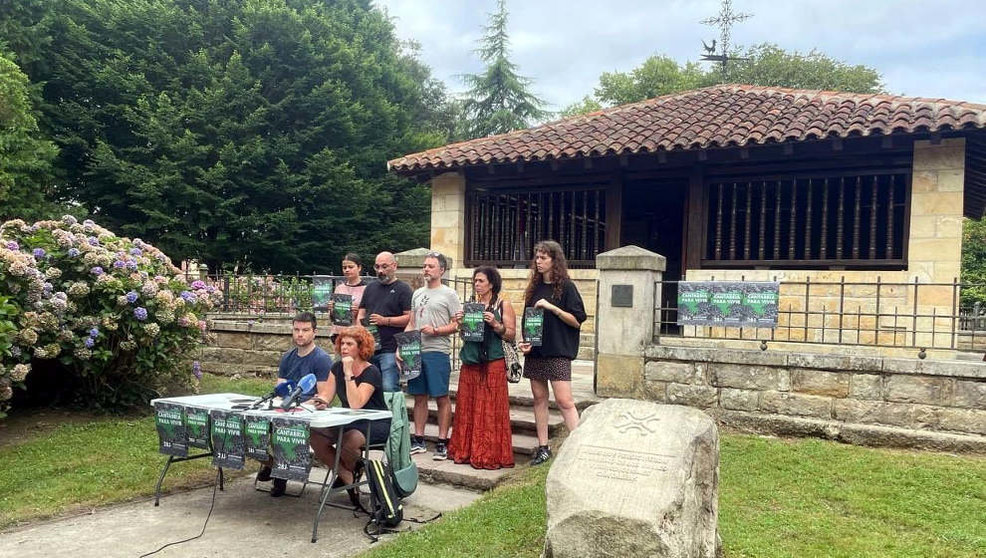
[[448, 266, 516, 469]]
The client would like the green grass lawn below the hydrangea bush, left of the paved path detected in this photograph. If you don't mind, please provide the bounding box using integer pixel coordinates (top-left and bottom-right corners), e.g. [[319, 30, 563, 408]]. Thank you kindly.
[[0, 375, 271, 528]]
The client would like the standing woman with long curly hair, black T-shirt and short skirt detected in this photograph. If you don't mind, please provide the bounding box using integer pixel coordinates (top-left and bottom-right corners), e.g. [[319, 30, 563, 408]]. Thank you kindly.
[[518, 240, 586, 465]]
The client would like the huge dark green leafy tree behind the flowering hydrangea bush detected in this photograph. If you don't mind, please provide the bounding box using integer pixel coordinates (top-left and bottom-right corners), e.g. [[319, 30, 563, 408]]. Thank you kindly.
[[0, 0, 448, 272]]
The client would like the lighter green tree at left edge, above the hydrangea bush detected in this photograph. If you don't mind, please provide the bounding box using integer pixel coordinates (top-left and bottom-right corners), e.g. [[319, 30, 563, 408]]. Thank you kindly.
[[0, 50, 58, 221]]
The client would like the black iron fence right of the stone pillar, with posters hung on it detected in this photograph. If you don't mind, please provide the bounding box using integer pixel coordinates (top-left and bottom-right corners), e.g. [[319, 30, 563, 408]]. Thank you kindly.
[[654, 278, 986, 350]]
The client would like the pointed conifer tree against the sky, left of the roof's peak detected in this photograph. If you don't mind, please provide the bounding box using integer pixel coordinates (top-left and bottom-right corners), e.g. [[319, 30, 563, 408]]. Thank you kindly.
[[462, 0, 550, 138]]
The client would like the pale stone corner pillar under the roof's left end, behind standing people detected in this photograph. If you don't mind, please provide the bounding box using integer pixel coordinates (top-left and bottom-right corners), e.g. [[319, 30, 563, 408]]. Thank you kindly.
[[431, 172, 466, 269]]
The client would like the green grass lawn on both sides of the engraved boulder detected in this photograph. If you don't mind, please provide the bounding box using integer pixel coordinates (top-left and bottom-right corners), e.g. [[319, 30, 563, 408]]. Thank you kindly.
[[364, 434, 986, 558]]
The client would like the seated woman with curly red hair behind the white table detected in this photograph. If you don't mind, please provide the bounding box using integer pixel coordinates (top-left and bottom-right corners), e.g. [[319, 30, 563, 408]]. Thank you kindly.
[[309, 326, 390, 496]]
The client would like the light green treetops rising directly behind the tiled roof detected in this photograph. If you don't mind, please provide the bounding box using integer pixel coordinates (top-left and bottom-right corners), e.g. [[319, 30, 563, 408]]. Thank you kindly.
[[562, 43, 883, 115]]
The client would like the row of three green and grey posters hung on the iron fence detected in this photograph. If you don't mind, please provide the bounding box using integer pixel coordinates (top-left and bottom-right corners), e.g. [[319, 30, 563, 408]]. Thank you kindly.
[[678, 281, 780, 328]]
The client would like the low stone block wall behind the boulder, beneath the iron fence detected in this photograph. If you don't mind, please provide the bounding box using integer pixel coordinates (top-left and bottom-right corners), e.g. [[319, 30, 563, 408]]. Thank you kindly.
[[640, 345, 986, 452]]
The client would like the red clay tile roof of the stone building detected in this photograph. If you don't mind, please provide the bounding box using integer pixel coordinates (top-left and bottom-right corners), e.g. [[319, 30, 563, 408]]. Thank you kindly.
[[387, 85, 986, 174]]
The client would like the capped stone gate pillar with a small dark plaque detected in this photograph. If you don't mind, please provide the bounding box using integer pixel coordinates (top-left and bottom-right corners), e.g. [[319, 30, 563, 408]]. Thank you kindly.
[[596, 246, 666, 397]]
